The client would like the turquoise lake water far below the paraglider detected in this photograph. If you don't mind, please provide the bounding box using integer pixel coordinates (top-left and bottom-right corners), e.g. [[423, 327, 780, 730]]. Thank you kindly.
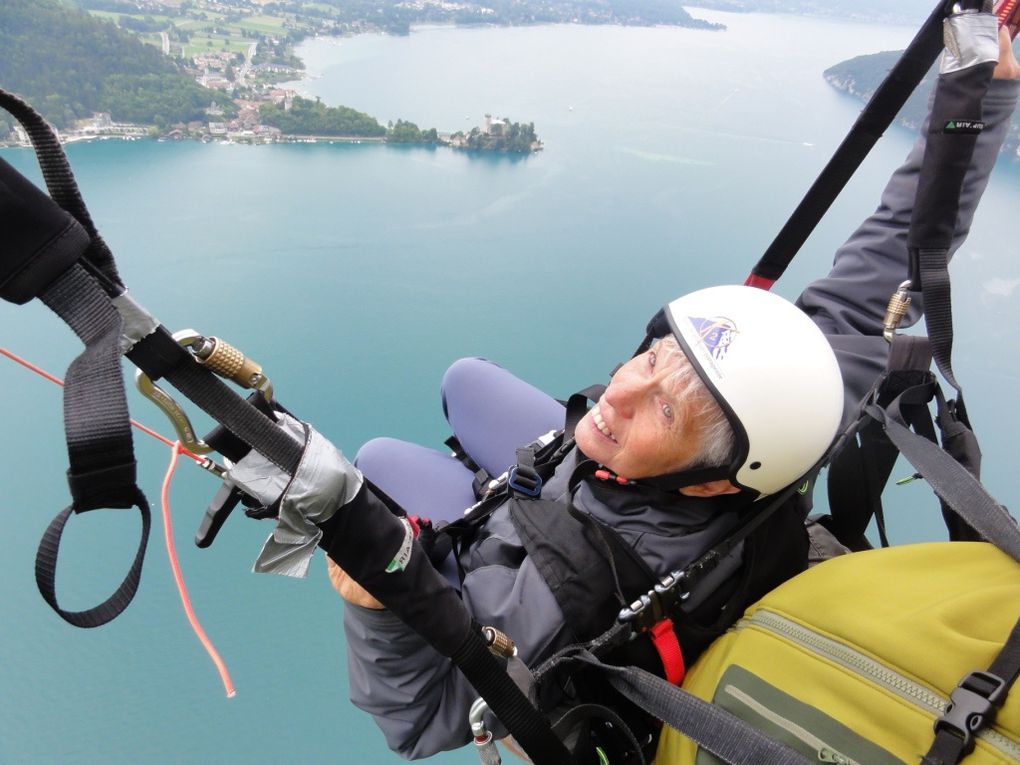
[[0, 11, 1020, 764]]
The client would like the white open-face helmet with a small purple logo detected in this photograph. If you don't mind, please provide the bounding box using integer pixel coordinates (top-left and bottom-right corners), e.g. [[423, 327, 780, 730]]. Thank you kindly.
[[649, 286, 844, 495]]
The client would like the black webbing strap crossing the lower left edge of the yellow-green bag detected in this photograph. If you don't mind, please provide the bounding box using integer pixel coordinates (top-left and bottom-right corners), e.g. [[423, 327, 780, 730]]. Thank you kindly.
[[576, 652, 811, 765]]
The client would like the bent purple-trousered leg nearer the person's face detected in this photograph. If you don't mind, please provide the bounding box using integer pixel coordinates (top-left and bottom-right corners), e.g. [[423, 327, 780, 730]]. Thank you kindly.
[[443, 359, 565, 475]]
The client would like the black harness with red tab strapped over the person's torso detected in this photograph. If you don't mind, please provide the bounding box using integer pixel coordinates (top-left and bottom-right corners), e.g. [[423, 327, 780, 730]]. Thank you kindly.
[[434, 386, 808, 763]]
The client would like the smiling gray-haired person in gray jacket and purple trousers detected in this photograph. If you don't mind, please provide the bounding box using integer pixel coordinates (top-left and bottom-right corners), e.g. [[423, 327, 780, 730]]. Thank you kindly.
[[318, 33, 1020, 758]]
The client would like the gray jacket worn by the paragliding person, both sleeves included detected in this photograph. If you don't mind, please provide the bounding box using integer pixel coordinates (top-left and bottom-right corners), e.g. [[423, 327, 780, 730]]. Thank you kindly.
[[344, 81, 1020, 759]]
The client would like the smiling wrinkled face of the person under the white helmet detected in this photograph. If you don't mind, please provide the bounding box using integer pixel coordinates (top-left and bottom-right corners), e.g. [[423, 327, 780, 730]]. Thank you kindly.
[[574, 348, 701, 478]]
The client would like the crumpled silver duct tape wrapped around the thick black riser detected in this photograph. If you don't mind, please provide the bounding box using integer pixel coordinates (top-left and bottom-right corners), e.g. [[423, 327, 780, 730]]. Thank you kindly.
[[227, 412, 363, 577]]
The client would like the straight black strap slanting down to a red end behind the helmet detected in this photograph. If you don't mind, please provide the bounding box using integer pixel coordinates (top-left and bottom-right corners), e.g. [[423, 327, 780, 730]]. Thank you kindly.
[[749, 0, 950, 286]]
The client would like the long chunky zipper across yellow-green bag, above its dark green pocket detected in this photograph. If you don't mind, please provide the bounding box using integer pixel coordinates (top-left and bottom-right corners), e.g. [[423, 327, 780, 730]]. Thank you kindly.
[[736, 609, 1020, 760]]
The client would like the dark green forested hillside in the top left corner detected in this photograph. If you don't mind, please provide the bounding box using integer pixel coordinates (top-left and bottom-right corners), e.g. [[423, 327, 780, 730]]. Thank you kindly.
[[0, 0, 219, 128]]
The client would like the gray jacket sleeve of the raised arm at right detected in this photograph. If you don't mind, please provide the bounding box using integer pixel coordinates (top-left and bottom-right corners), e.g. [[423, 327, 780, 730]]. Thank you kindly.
[[798, 80, 1020, 414]]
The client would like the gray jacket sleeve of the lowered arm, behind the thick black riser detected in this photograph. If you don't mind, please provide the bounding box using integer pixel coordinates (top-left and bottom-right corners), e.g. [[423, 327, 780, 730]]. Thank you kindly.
[[344, 560, 565, 759]]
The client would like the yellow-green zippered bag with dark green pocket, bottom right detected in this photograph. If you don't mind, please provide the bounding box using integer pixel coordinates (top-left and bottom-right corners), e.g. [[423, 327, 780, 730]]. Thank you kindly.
[[655, 543, 1020, 765]]
